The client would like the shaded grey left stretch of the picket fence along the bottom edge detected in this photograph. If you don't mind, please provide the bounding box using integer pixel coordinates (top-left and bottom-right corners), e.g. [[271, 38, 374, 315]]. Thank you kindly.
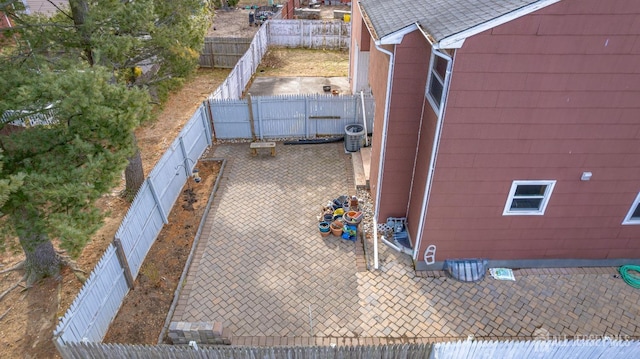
[[56, 343, 432, 359]]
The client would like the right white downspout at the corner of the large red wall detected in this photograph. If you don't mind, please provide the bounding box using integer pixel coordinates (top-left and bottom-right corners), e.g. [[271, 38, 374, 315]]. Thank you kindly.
[[413, 43, 453, 261]]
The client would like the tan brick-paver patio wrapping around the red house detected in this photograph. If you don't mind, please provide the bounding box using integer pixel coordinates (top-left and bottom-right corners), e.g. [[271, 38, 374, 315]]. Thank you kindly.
[[173, 143, 640, 345]]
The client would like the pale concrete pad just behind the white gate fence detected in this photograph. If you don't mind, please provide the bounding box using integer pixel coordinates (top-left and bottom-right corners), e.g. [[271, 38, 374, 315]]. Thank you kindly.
[[248, 77, 351, 96]]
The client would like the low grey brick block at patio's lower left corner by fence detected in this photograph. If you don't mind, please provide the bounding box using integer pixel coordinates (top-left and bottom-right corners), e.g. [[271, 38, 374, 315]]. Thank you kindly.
[[169, 322, 231, 345]]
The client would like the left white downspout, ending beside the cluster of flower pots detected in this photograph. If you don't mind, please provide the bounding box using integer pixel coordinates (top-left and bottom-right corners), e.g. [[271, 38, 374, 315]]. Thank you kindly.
[[373, 43, 395, 269]]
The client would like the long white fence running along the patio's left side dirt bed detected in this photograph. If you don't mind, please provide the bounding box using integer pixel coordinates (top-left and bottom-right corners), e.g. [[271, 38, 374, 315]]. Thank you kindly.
[[54, 105, 211, 353]]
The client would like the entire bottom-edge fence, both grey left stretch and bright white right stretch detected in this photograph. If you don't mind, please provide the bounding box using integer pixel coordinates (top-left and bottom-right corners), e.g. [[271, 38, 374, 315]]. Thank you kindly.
[[56, 340, 640, 359]]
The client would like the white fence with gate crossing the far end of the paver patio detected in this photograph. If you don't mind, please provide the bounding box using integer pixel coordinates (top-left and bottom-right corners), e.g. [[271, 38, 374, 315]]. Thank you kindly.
[[209, 94, 374, 139]]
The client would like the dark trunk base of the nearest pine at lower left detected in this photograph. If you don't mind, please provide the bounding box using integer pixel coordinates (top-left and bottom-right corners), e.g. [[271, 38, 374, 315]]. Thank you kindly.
[[16, 210, 61, 286]]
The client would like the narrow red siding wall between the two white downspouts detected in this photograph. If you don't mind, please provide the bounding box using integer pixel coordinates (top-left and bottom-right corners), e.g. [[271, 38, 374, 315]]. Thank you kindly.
[[370, 31, 430, 225]]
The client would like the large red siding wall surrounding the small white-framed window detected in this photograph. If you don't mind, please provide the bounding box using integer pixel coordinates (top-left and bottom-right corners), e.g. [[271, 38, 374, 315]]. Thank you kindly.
[[418, 0, 640, 260]]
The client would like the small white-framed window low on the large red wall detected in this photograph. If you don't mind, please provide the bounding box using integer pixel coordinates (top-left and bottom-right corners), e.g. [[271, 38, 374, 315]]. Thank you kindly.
[[502, 180, 556, 216]]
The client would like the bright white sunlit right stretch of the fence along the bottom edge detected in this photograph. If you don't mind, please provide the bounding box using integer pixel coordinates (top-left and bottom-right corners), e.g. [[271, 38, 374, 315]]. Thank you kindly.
[[430, 336, 640, 359]]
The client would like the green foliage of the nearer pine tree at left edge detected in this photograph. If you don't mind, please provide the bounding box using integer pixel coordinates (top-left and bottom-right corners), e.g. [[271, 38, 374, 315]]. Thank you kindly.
[[0, 61, 149, 284]]
